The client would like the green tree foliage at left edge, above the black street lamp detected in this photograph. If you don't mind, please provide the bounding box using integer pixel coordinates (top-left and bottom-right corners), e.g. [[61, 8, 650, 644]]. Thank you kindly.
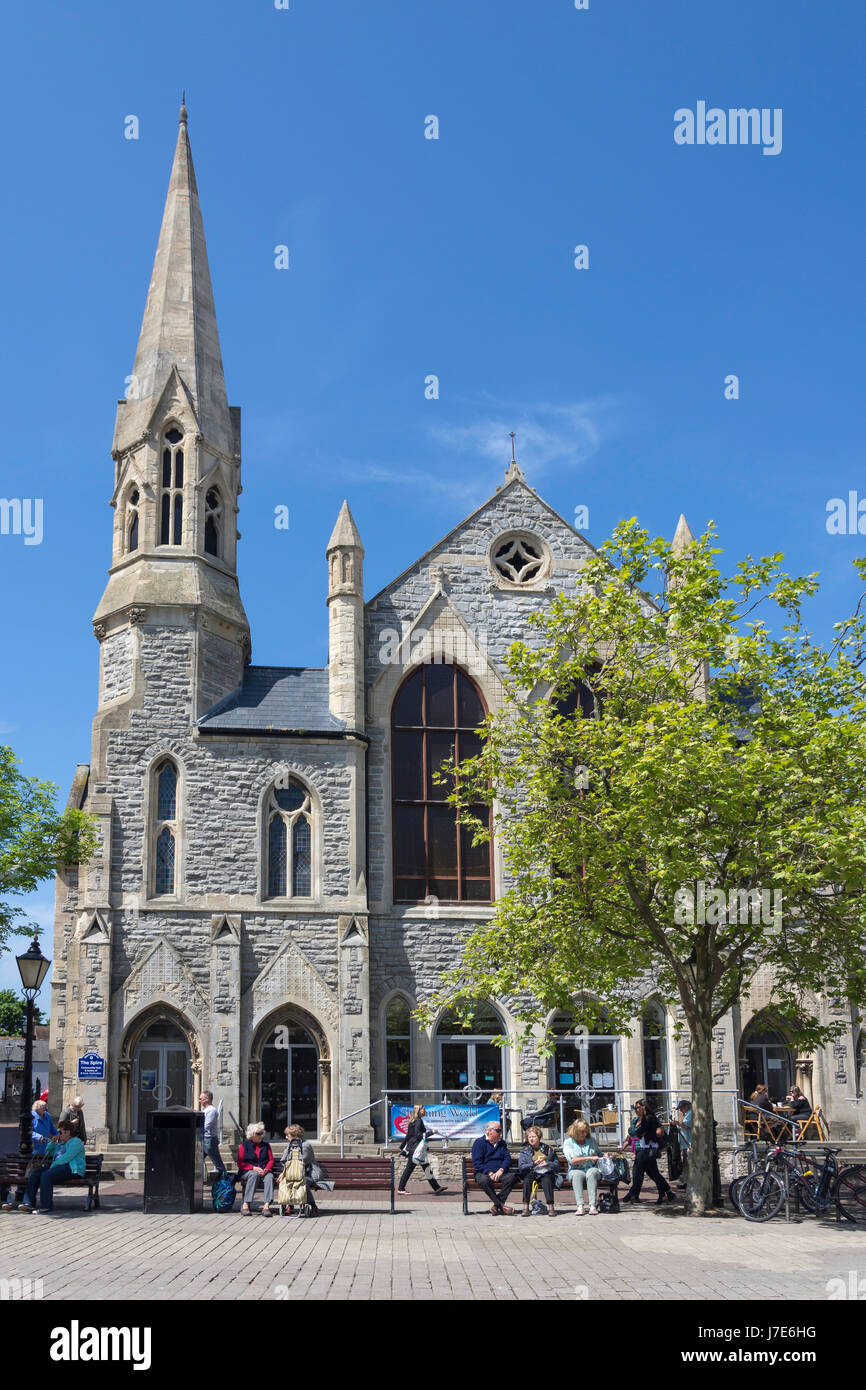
[[0, 746, 97, 947]]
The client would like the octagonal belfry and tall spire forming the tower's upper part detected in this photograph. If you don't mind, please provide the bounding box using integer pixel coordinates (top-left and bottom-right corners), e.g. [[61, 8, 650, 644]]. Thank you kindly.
[[93, 107, 250, 720]]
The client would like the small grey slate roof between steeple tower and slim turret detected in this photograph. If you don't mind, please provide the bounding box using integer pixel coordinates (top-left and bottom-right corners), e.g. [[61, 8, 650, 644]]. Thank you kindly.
[[197, 666, 346, 734]]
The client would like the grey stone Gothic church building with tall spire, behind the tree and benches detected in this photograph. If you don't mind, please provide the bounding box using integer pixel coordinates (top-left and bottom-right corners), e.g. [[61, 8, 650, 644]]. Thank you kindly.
[[50, 108, 863, 1143]]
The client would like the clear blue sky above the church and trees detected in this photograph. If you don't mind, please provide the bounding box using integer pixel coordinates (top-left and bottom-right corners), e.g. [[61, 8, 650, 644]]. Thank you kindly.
[[0, 0, 866, 986]]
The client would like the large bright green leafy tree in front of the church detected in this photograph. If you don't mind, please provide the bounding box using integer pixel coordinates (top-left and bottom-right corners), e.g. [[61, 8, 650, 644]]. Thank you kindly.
[[423, 520, 866, 1215]]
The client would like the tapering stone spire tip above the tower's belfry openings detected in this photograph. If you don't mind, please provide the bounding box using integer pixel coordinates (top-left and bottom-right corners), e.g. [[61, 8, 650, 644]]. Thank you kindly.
[[114, 104, 236, 455]]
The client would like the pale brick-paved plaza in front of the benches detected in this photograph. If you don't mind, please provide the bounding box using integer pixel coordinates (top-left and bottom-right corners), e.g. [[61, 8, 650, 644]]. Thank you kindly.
[[0, 1183, 866, 1302]]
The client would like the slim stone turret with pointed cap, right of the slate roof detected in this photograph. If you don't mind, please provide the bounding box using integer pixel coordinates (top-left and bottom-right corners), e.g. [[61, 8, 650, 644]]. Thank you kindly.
[[327, 502, 364, 734]]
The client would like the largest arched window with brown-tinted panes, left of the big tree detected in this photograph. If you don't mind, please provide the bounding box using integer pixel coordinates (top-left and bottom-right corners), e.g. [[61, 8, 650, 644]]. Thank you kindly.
[[391, 664, 492, 902]]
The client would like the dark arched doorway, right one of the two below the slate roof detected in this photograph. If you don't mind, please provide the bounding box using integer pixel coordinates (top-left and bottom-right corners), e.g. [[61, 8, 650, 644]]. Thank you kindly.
[[256, 1016, 320, 1140]]
